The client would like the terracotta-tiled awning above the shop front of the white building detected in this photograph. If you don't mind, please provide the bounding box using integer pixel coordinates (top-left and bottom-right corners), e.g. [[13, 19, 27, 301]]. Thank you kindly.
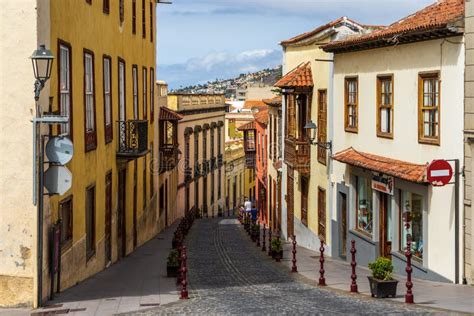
[[332, 147, 427, 183]]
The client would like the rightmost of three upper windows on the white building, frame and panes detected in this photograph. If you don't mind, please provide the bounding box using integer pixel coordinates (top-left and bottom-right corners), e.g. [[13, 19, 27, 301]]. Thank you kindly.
[[418, 73, 440, 145]]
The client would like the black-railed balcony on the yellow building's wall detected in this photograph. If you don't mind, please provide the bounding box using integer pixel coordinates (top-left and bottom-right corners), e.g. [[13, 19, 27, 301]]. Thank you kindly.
[[117, 120, 149, 160]]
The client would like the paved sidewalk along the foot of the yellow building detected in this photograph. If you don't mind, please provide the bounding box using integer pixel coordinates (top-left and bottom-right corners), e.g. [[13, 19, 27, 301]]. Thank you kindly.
[[0, 222, 179, 315]]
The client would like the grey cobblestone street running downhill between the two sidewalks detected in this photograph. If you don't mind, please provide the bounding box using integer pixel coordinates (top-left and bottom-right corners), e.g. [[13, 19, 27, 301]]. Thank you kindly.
[[133, 219, 436, 315]]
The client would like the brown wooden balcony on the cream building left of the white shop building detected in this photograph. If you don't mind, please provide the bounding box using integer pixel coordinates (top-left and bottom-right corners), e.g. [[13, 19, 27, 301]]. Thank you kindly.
[[285, 138, 311, 174]]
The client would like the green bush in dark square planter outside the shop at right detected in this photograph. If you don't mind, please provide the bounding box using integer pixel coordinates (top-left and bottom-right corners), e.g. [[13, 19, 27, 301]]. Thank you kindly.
[[367, 257, 398, 298]]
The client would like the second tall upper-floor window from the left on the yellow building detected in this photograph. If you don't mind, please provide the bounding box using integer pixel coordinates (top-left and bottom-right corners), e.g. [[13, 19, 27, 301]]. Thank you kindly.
[[84, 50, 97, 151]]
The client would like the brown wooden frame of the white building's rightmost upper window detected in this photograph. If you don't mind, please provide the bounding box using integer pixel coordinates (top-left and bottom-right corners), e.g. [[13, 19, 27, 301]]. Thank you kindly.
[[418, 71, 441, 146]]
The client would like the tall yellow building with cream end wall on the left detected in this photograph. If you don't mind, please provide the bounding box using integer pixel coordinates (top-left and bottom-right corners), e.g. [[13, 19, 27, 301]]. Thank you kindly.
[[0, 0, 159, 306]]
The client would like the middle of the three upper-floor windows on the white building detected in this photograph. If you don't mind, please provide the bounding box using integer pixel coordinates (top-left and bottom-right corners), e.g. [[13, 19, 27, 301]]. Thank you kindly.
[[377, 76, 393, 138]]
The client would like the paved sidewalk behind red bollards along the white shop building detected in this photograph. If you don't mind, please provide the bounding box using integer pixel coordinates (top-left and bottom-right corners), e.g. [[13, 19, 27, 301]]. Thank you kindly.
[[282, 243, 474, 313]]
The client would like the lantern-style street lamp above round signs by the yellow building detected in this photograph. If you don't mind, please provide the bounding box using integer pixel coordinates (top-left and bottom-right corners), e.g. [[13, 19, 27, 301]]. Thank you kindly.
[[30, 45, 54, 101]]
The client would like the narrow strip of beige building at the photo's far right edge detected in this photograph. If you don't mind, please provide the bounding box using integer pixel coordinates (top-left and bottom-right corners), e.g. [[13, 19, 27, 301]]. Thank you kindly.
[[463, 0, 474, 284]]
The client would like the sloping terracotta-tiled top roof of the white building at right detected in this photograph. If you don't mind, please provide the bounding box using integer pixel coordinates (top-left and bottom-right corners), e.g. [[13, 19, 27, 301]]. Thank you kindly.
[[323, 0, 464, 51]]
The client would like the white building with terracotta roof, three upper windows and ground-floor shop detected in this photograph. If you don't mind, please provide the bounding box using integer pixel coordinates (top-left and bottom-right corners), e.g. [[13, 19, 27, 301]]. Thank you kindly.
[[323, 0, 465, 282]]
